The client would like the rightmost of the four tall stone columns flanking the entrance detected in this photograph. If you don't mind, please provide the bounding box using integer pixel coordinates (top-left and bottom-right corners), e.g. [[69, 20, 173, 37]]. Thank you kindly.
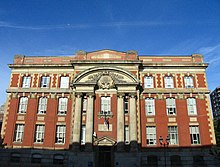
[[129, 94, 137, 151]]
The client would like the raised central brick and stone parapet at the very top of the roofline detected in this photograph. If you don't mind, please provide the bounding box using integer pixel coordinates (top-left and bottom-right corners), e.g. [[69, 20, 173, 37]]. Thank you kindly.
[[75, 49, 138, 60]]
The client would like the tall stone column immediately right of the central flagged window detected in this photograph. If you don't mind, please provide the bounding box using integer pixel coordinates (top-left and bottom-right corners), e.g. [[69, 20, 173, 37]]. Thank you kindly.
[[117, 94, 124, 151]]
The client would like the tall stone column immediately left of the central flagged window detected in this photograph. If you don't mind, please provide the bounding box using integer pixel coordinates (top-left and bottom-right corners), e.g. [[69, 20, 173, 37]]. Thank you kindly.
[[85, 94, 94, 151]]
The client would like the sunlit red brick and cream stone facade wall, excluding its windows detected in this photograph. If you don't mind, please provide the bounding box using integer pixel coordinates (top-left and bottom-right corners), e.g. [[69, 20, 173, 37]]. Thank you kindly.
[[1, 50, 215, 149]]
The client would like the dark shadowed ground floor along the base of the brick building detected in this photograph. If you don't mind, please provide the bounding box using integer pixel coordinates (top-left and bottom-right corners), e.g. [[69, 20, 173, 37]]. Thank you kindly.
[[0, 146, 220, 167]]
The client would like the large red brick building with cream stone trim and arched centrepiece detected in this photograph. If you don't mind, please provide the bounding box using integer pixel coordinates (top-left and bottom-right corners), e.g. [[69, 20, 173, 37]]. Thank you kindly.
[[1, 50, 215, 166]]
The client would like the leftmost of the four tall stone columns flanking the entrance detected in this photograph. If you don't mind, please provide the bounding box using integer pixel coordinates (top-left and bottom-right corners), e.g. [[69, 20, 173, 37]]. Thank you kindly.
[[73, 94, 82, 150]]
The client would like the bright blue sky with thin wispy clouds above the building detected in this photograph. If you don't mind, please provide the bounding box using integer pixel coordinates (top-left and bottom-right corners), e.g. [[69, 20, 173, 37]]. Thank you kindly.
[[0, 0, 220, 104]]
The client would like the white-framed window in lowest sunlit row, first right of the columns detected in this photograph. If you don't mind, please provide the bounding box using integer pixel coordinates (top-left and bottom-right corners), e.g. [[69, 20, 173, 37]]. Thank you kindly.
[[146, 126, 157, 145]]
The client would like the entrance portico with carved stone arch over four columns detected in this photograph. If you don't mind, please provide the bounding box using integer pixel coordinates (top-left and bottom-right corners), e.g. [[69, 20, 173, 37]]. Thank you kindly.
[[72, 66, 139, 151]]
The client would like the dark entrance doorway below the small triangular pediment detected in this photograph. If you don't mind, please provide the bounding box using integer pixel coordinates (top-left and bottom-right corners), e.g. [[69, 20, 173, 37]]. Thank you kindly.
[[96, 146, 113, 167]]
